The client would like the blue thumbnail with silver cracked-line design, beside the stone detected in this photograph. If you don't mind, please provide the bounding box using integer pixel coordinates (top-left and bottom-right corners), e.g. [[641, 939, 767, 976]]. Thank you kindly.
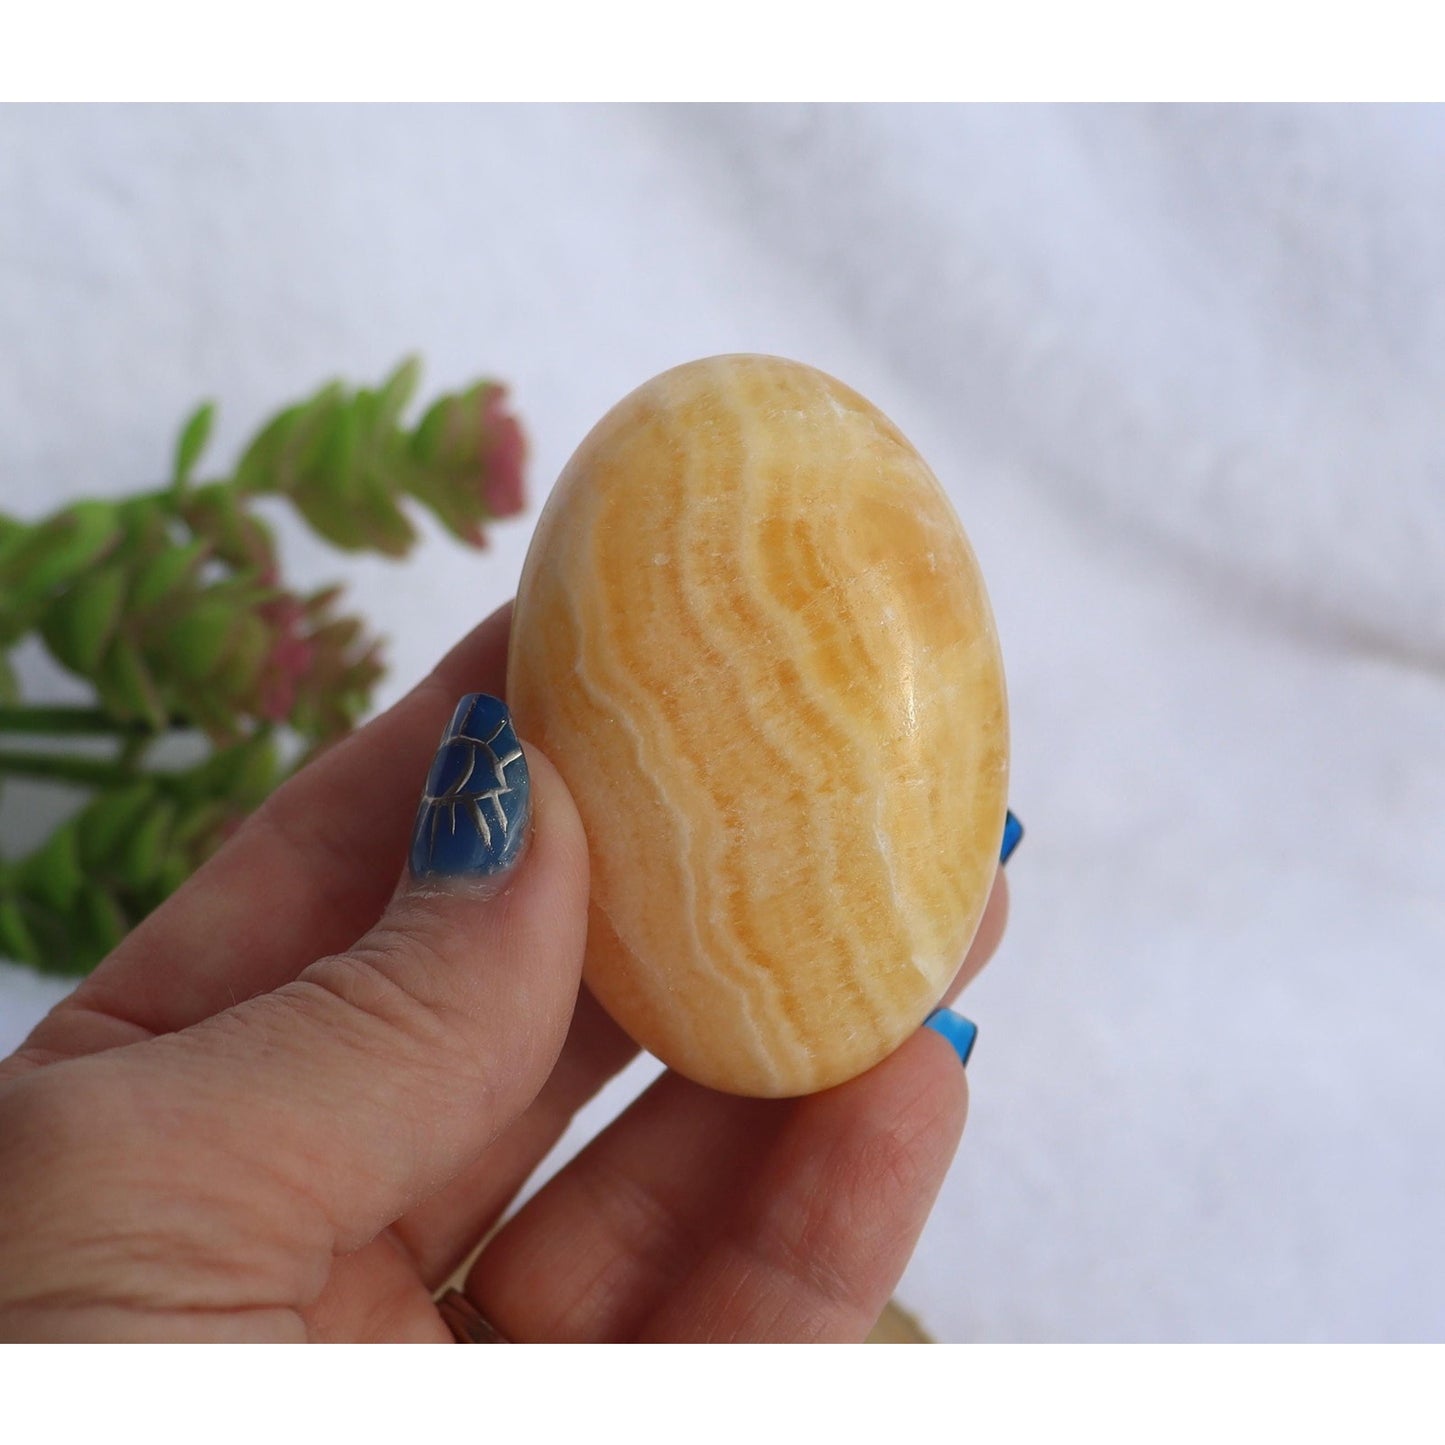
[[410, 692, 532, 879]]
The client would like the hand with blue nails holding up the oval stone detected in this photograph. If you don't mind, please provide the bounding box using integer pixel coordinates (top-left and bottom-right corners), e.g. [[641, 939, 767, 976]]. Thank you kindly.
[[0, 608, 1007, 1341]]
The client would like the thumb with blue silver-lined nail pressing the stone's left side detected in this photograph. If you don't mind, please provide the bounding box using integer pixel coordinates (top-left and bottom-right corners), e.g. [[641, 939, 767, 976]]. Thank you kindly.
[[136, 694, 587, 1250]]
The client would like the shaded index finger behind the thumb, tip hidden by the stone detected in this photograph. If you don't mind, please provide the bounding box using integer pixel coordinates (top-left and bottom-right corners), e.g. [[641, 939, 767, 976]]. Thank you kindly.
[[8, 604, 512, 1062]]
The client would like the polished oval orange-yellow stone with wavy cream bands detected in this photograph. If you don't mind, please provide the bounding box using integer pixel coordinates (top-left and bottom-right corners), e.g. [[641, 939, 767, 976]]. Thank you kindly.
[[507, 355, 1009, 1095]]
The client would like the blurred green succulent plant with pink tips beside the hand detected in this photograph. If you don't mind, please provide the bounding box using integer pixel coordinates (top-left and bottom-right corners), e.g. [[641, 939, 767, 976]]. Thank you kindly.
[[0, 360, 525, 974]]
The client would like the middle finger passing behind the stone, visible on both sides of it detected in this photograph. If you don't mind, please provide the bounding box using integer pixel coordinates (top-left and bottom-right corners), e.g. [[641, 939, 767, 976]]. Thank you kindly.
[[396, 870, 1009, 1285]]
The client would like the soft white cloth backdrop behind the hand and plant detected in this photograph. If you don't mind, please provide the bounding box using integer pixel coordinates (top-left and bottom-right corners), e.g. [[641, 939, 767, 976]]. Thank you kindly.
[[0, 107, 1445, 1341]]
